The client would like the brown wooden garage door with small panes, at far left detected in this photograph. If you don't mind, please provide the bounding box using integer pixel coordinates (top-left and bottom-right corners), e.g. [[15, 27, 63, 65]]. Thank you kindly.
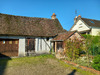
[[0, 39, 18, 57]]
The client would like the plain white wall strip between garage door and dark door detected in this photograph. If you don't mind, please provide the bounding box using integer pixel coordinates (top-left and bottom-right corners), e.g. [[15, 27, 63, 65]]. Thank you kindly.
[[18, 38, 25, 56]]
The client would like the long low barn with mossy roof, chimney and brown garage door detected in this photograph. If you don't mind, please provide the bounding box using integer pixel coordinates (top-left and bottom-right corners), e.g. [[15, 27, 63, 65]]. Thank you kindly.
[[0, 13, 66, 56]]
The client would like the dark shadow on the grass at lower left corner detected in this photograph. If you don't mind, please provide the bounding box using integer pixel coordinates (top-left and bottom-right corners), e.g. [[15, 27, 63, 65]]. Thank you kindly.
[[0, 53, 11, 75]]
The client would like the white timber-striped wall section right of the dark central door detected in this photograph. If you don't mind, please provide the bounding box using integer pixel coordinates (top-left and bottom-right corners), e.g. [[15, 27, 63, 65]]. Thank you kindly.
[[35, 37, 52, 53]]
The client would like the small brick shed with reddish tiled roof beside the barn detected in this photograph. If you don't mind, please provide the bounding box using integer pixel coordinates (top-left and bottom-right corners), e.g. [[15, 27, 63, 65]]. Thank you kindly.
[[52, 31, 83, 53]]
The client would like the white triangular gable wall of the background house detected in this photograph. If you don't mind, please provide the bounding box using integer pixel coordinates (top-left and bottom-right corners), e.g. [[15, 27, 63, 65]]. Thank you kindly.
[[71, 20, 90, 32]]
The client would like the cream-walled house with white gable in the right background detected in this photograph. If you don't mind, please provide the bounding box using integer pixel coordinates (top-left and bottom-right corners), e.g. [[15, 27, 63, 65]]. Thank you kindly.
[[70, 15, 100, 36]]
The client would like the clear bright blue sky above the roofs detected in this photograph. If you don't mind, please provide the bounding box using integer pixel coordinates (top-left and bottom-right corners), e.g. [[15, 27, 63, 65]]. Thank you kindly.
[[0, 0, 100, 31]]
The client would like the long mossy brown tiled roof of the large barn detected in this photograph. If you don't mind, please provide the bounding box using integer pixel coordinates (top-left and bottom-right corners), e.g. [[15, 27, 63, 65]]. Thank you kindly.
[[0, 14, 66, 37]]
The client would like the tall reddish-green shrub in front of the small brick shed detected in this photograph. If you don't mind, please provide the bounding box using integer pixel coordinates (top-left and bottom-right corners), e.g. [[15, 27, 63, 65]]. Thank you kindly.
[[65, 39, 82, 61]]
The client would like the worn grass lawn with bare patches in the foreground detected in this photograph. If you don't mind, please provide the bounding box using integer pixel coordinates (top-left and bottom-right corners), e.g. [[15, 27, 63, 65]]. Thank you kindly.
[[0, 55, 96, 75]]
